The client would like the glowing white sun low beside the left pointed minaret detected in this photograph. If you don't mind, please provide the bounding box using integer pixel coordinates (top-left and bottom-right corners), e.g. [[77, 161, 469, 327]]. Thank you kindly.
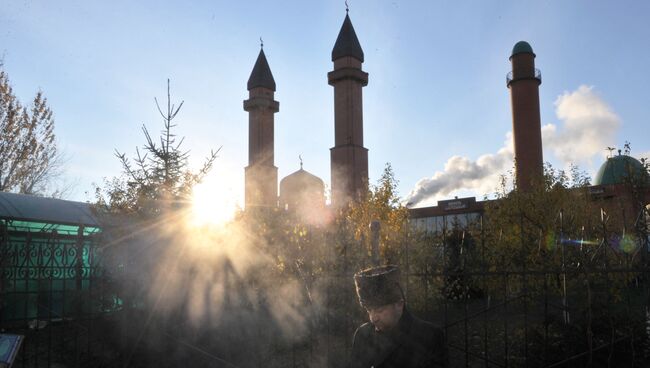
[[190, 175, 239, 226]]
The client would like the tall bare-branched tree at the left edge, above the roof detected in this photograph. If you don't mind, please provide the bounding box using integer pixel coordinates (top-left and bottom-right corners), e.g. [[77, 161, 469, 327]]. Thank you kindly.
[[0, 63, 62, 195]]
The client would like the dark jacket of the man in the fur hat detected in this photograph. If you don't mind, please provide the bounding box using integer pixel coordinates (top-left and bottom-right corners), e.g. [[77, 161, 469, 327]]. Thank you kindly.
[[349, 307, 448, 368]]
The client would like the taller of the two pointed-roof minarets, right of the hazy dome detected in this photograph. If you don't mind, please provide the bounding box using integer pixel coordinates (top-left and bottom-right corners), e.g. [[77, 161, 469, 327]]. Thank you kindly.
[[327, 14, 368, 207]]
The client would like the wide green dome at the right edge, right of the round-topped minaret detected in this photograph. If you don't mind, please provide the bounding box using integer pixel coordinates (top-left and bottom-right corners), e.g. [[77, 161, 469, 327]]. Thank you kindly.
[[594, 155, 650, 185]]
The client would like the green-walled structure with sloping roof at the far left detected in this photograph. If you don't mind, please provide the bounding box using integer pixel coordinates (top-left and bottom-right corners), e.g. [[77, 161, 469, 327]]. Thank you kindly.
[[0, 193, 105, 326]]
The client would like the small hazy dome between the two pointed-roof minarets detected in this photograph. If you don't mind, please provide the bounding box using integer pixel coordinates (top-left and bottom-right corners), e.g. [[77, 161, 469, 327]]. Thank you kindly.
[[280, 165, 325, 210]]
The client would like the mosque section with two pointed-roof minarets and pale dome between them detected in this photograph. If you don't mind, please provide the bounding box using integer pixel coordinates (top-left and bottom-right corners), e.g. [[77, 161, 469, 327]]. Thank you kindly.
[[244, 10, 368, 216]]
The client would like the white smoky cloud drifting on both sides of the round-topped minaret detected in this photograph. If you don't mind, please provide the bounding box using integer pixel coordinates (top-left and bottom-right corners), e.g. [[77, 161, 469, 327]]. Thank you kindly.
[[406, 85, 621, 206]]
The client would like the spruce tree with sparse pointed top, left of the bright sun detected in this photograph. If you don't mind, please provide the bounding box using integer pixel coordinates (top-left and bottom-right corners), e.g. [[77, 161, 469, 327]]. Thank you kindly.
[[90, 80, 219, 366]]
